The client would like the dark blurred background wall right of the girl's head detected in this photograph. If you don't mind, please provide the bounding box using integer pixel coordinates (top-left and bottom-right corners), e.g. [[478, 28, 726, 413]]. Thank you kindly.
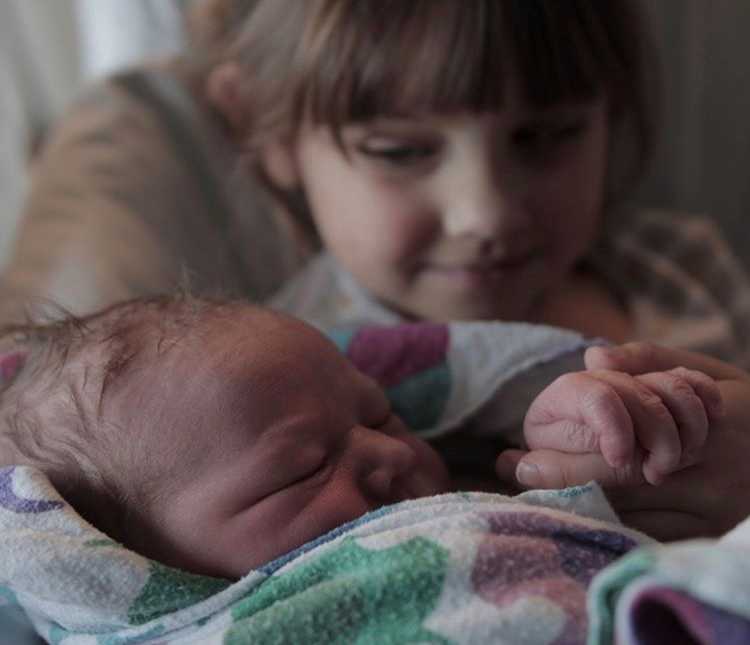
[[639, 0, 750, 269]]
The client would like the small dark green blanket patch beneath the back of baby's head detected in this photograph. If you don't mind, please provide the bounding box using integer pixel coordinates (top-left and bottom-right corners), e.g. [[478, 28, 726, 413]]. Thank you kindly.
[[128, 561, 230, 625]]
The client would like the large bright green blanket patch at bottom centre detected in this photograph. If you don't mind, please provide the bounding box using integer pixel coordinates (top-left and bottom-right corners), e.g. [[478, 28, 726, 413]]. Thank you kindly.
[[224, 537, 451, 645]]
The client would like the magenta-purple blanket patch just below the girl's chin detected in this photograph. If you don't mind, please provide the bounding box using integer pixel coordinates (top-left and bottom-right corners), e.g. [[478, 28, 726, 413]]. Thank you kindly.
[[346, 323, 450, 387]]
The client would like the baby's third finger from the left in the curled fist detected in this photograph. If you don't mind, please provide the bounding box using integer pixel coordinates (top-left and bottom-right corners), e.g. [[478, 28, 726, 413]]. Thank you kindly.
[[635, 367, 721, 468]]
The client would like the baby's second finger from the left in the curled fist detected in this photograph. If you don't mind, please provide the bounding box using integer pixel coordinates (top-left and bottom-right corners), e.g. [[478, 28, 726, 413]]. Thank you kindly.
[[590, 370, 682, 484]]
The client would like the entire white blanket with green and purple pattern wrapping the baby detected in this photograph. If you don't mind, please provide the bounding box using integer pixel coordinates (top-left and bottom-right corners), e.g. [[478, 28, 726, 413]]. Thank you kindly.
[[0, 323, 750, 645]]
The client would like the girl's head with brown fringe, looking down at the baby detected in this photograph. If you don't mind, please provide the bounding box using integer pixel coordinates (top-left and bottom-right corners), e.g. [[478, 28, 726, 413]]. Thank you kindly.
[[206, 0, 653, 320]]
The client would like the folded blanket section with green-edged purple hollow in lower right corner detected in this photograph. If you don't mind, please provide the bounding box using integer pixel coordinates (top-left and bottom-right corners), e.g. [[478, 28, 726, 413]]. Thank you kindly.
[[589, 519, 750, 645]]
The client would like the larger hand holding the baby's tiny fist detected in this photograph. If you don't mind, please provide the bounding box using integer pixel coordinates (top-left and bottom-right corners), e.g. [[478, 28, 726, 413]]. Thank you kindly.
[[497, 343, 750, 541]]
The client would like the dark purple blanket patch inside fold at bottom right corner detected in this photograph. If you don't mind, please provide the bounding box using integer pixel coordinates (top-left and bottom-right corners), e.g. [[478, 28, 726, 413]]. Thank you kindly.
[[629, 587, 750, 645]]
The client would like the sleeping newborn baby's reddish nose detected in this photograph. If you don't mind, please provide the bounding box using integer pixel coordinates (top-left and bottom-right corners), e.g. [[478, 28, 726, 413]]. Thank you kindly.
[[351, 426, 417, 502]]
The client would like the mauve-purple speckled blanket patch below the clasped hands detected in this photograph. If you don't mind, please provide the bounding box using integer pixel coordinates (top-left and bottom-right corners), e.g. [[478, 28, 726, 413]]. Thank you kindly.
[[472, 512, 636, 645]]
